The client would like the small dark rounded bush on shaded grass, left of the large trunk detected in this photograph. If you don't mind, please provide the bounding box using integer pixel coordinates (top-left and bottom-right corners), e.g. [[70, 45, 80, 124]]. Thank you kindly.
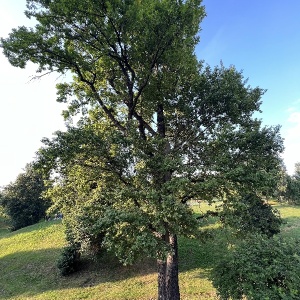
[[57, 245, 80, 276]]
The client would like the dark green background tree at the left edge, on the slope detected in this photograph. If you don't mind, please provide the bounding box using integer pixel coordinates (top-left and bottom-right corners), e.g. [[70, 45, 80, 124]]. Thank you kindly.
[[0, 164, 50, 230]]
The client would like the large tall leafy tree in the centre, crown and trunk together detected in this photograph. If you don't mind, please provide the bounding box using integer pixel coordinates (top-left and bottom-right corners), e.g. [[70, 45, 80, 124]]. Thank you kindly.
[[1, 0, 282, 300]]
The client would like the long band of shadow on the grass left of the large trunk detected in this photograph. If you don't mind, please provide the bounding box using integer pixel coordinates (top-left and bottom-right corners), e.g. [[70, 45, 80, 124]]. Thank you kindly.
[[0, 248, 156, 299]]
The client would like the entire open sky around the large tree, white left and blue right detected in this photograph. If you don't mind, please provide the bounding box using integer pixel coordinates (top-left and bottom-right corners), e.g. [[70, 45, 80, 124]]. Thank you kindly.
[[0, 0, 300, 186]]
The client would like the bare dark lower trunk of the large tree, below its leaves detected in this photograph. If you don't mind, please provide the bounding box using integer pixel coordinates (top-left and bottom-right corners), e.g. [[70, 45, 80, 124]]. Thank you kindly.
[[157, 235, 180, 300]]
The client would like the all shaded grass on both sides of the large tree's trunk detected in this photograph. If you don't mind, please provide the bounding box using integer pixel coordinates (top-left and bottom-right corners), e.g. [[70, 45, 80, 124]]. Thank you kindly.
[[0, 218, 227, 299]]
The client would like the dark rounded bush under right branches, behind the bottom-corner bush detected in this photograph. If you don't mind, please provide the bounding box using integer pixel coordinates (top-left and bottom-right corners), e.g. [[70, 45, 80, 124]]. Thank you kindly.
[[220, 194, 282, 237]]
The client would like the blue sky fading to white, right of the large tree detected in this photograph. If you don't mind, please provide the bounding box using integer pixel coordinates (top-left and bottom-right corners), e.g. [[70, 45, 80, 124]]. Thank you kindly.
[[197, 0, 300, 173]]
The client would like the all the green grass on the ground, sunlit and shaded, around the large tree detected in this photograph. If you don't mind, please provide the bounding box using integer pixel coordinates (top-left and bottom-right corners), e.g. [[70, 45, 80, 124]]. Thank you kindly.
[[0, 205, 300, 300]]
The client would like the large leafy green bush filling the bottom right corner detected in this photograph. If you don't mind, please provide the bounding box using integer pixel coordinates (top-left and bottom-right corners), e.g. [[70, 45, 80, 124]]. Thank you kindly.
[[212, 235, 300, 300]]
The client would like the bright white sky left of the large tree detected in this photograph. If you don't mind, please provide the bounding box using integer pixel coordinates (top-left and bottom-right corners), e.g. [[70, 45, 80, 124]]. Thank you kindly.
[[0, 0, 65, 187]]
